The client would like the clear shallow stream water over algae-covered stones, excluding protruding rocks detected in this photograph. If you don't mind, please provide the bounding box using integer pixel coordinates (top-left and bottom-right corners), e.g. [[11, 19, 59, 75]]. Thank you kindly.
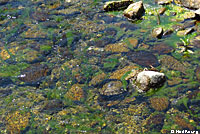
[[0, 0, 200, 134]]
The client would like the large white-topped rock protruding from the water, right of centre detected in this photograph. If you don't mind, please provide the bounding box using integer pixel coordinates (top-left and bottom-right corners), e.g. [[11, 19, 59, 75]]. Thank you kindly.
[[130, 71, 166, 92]]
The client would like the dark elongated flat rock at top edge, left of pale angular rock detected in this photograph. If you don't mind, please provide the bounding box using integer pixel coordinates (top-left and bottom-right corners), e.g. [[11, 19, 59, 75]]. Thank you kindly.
[[103, 0, 133, 11]]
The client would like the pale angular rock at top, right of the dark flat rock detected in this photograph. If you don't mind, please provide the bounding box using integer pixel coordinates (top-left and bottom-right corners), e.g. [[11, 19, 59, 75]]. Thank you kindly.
[[124, 1, 145, 19]]
